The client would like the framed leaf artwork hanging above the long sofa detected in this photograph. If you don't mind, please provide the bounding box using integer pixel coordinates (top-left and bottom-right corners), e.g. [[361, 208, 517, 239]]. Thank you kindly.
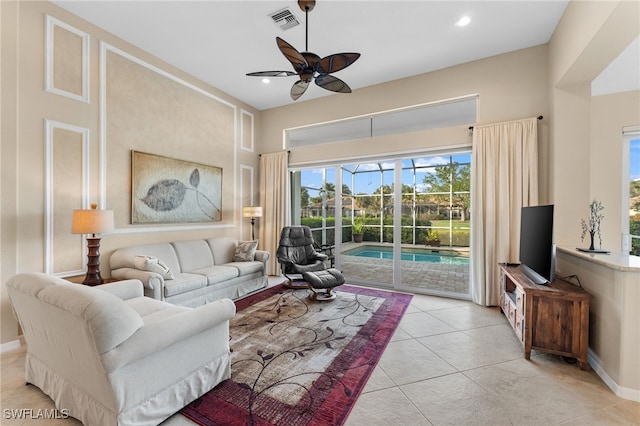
[[131, 151, 222, 224]]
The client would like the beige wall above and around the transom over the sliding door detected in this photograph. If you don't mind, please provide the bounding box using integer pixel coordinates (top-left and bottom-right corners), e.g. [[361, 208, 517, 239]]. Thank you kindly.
[[260, 45, 549, 199]]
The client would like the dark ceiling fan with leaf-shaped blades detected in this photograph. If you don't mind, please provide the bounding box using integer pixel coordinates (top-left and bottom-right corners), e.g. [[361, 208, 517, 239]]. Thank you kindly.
[[247, 0, 360, 101]]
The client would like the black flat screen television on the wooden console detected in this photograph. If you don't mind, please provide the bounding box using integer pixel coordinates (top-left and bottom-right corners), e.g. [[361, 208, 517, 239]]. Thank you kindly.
[[520, 204, 556, 285]]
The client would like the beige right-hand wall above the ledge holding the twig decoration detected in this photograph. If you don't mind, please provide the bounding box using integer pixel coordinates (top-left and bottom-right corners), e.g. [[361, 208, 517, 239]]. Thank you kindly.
[[549, 1, 640, 246]]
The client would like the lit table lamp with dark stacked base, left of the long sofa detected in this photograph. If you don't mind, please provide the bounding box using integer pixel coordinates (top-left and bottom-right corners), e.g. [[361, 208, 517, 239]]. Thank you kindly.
[[71, 203, 113, 286]]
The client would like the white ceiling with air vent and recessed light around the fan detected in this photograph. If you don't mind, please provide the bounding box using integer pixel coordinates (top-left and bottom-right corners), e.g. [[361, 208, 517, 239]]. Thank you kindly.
[[53, 0, 568, 110]]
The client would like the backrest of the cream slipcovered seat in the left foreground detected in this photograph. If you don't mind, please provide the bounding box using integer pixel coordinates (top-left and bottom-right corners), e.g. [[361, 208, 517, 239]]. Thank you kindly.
[[7, 273, 143, 409]]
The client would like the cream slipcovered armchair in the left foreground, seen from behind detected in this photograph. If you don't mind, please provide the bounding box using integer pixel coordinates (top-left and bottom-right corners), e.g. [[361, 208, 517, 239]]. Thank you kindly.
[[7, 273, 235, 426]]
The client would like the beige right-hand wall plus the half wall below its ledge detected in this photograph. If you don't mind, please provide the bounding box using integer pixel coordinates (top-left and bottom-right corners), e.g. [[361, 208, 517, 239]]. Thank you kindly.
[[549, 1, 640, 400]]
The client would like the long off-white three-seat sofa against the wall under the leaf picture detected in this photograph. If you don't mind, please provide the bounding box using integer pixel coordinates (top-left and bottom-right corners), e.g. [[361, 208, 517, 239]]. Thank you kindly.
[[109, 237, 269, 307]]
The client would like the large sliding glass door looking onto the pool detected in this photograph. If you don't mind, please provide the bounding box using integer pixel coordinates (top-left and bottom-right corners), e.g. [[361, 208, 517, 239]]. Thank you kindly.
[[292, 152, 471, 298]]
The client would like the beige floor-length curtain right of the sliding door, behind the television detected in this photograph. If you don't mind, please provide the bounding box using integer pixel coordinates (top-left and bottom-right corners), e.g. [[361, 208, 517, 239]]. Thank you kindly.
[[471, 117, 538, 306]]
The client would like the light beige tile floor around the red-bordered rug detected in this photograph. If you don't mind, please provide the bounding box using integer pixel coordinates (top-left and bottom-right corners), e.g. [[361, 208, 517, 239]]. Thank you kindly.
[[0, 295, 640, 426]]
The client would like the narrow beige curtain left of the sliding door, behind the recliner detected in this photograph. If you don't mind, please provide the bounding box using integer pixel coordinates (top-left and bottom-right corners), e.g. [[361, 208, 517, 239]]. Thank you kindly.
[[259, 151, 290, 275]]
